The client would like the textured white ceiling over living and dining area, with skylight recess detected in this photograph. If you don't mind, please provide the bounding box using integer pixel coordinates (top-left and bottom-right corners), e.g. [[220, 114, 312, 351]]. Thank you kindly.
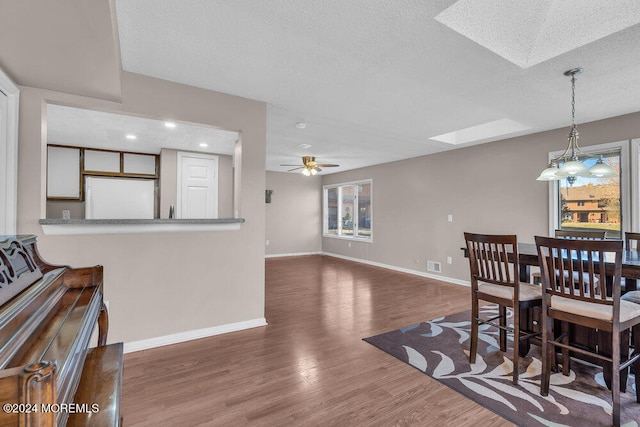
[[116, 0, 640, 173]]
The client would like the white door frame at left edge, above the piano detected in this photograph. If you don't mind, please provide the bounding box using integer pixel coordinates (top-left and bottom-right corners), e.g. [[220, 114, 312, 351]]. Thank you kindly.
[[0, 69, 20, 235]]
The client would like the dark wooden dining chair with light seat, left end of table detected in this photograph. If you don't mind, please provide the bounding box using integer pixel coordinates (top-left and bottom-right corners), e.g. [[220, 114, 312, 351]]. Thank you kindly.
[[464, 233, 542, 384]]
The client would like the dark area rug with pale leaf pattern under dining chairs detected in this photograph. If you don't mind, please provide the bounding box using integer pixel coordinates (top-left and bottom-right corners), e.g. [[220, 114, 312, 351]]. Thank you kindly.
[[364, 307, 640, 427]]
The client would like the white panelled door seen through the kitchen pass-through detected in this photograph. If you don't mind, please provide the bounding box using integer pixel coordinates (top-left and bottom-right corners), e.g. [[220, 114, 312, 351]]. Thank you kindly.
[[176, 152, 218, 219]]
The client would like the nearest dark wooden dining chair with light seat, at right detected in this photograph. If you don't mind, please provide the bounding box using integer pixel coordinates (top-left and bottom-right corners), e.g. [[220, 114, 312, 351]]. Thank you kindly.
[[535, 236, 640, 426]]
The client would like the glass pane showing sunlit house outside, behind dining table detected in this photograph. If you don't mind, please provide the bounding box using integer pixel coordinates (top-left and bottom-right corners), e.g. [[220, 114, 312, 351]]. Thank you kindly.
[[558, 152, 622, 239]]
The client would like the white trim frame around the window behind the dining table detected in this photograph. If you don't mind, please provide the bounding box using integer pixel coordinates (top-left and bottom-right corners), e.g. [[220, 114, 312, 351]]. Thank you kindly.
[[549, 140, 640, 238]]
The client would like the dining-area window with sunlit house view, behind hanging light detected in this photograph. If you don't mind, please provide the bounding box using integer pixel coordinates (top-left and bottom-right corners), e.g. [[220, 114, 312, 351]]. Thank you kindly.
[[549, 141, 630, 239]]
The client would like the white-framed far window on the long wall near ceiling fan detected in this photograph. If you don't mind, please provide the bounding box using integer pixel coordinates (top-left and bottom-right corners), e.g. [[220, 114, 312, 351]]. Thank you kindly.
[[323, 180, 372, 240]]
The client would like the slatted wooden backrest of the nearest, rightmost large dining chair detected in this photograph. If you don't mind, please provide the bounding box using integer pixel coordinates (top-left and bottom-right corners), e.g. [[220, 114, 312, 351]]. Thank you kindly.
[[535, 236, 622, 305]]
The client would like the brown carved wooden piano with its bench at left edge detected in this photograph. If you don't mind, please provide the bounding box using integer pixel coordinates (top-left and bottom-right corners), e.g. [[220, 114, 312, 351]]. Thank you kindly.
[[0, 236, 123, 427]]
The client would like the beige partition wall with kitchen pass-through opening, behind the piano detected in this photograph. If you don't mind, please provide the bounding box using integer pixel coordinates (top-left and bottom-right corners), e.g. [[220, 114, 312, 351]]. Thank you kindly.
[[17, 72, 266, 342]]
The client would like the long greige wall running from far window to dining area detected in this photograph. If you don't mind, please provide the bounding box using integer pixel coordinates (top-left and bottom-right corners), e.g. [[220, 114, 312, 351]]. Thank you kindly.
[[322, 113, 640, 282]]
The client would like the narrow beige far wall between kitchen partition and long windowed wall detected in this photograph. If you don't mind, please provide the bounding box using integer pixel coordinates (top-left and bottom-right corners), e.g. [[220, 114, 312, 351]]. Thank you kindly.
[[265, 172, 322, 256]]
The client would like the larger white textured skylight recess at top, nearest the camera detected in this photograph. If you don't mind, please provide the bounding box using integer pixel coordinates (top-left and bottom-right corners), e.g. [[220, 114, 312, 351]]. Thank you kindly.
[[436, 0, 640, 68]]
